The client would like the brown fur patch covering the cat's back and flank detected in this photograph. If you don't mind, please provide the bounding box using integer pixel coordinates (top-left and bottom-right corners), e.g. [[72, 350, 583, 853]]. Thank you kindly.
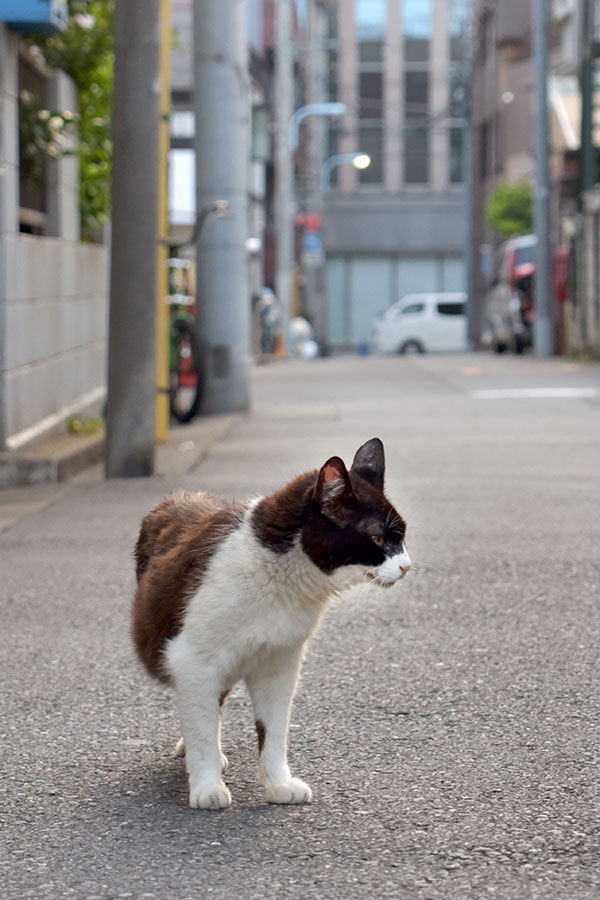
[[131, 493, 245, 681]]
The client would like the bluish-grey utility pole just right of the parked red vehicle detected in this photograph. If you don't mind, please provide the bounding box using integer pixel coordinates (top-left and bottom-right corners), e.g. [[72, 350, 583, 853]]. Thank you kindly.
[[531, 0, 554, 356]]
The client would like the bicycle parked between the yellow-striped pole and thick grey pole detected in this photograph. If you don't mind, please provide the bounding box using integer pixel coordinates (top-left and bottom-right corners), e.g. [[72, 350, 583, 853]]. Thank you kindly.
[[166, 200, 229, 424]]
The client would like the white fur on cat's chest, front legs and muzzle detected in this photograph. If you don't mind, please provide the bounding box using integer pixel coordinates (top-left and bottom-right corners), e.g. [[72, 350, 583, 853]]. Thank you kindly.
[[165, 498, 410, 809]]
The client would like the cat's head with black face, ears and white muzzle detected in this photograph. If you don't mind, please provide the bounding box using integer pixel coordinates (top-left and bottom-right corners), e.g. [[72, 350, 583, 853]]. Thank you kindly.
[[301, 438, 410, 585]]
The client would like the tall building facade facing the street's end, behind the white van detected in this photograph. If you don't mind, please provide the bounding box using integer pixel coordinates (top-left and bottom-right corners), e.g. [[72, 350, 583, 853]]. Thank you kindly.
[[323, 0, 471, 348]]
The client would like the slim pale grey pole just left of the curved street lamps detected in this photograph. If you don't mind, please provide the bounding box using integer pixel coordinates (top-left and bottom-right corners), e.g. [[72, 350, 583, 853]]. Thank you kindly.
[[275, 0, 294, 340]]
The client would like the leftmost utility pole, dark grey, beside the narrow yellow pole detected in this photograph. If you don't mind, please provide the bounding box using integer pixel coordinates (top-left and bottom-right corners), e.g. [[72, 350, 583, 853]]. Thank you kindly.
[[106, 0, 160, 478]]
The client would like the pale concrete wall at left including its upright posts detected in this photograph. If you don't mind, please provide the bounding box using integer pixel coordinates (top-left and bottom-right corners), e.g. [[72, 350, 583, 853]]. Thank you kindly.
[[0, 24, 109, 448]]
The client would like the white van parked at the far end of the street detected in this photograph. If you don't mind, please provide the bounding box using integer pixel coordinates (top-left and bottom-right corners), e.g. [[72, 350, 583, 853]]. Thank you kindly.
[[372, 294, 467, 353]]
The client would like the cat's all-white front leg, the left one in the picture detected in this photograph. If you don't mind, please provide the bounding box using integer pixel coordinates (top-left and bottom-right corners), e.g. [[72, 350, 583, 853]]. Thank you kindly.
[[168, 639, 231, 809]]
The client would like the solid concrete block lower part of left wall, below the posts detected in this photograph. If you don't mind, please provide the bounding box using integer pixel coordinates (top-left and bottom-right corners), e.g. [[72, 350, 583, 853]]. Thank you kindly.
[[4, 235, 108, 447]]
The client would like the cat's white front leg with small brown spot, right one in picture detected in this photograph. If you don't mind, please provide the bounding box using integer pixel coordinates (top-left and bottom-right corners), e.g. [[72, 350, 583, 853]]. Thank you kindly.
[[246, 644, 312, 803]]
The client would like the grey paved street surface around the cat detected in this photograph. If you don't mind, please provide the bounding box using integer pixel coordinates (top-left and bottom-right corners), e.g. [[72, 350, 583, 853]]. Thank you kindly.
[[0, 355, 600, 900]]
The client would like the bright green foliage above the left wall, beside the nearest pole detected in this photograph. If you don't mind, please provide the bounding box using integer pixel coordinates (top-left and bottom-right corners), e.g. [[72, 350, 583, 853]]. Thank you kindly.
[[28, 0, 114, 239]]
